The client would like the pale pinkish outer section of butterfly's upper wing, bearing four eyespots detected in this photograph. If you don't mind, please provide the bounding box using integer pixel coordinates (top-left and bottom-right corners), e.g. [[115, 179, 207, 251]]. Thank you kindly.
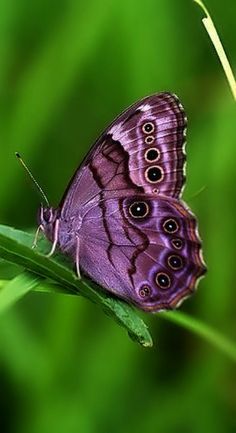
[[109, 93, 186, 197]]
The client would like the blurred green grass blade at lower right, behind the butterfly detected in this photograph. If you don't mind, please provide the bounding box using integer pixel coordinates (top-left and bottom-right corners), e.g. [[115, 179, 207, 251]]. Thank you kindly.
[[159, 311, 236, 362]]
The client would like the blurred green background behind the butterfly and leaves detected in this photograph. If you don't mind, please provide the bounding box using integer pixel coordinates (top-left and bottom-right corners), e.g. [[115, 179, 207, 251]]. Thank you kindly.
[[0, 0, 236, 433]]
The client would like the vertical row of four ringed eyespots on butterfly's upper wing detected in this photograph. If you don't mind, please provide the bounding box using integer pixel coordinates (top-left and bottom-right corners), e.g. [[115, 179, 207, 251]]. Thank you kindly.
[[142, 122, 164, 183]]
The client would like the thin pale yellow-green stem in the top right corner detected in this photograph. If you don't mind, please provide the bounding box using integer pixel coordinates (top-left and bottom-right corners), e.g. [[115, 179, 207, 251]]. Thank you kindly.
[[193, 0, 236, 100]]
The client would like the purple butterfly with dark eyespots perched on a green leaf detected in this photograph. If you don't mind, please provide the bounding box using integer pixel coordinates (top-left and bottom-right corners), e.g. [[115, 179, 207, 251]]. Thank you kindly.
[[38, 92, 206, 311]]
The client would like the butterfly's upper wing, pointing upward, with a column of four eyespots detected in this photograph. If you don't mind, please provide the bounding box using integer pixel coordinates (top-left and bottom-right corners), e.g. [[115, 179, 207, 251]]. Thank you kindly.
[[60, 92, 187, 216]]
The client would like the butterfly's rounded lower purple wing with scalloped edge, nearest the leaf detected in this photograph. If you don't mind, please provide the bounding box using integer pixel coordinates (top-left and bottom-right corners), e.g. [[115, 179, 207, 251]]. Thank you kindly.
[[78, 194, 205, 311]]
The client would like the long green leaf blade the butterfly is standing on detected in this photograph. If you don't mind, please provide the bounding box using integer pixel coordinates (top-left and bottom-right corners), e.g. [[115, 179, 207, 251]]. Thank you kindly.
[[0, 225, 152, 347]]
